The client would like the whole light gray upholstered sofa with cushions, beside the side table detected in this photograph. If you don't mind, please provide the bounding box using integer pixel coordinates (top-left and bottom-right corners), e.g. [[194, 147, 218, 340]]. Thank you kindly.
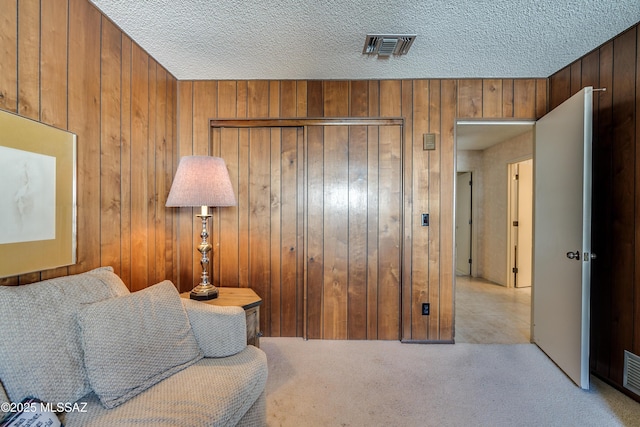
[[0, 267, 267, 427]]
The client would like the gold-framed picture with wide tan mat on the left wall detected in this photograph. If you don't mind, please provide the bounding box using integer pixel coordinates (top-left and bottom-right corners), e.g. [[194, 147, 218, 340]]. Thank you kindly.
[[0, 111, 77, 277]]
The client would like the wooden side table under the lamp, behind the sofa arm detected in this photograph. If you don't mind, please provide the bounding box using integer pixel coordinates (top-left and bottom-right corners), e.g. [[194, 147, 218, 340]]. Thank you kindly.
[[180, 288, 262, 348]]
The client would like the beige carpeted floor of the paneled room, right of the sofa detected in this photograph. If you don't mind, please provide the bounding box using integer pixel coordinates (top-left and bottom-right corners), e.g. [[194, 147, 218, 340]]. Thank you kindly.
[[261, 338, 640, 427]]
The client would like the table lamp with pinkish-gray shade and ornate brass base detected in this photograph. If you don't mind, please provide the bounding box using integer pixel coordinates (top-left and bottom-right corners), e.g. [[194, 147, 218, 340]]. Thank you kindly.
[[166, 156, 236, 300]]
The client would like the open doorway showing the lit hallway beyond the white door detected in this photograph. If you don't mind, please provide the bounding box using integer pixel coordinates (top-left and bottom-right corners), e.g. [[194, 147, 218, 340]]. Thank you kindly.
[[454, 120, 534, 344]]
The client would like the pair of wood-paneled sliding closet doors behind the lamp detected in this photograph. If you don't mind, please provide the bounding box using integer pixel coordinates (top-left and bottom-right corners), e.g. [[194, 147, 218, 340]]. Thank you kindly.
[[211, 119, 402, 340]]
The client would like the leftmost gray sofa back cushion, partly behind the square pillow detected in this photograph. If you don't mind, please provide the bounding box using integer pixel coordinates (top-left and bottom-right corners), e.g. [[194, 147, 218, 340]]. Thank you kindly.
[[0, 267, 129, 402]]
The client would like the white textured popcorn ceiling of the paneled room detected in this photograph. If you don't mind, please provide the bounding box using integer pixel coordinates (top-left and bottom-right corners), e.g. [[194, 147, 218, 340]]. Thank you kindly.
[[92, 0, 640, 80]]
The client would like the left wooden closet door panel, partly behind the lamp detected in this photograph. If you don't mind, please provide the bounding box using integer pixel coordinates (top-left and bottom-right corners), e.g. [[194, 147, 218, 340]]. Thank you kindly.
[[212, 127, 304, 336]]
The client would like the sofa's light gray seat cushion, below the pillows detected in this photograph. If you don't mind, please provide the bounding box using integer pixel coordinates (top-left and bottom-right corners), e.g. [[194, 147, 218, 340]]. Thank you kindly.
[[62, 345, 267, 427]]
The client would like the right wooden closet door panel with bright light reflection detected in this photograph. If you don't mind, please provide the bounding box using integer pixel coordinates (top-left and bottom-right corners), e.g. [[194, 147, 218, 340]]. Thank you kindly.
[[305, 126, 402, 339]]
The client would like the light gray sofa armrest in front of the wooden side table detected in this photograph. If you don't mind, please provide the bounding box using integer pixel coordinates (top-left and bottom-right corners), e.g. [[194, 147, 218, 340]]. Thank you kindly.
[[182, 298, 247, 357]]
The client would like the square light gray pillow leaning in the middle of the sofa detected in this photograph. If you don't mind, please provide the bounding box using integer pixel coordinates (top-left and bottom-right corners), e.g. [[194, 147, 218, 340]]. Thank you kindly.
[[78, 280, 203, 408]]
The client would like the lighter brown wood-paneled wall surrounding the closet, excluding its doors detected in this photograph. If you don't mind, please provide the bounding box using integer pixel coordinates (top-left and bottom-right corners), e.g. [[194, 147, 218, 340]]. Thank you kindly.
[[0, 0, 547, 342]]
